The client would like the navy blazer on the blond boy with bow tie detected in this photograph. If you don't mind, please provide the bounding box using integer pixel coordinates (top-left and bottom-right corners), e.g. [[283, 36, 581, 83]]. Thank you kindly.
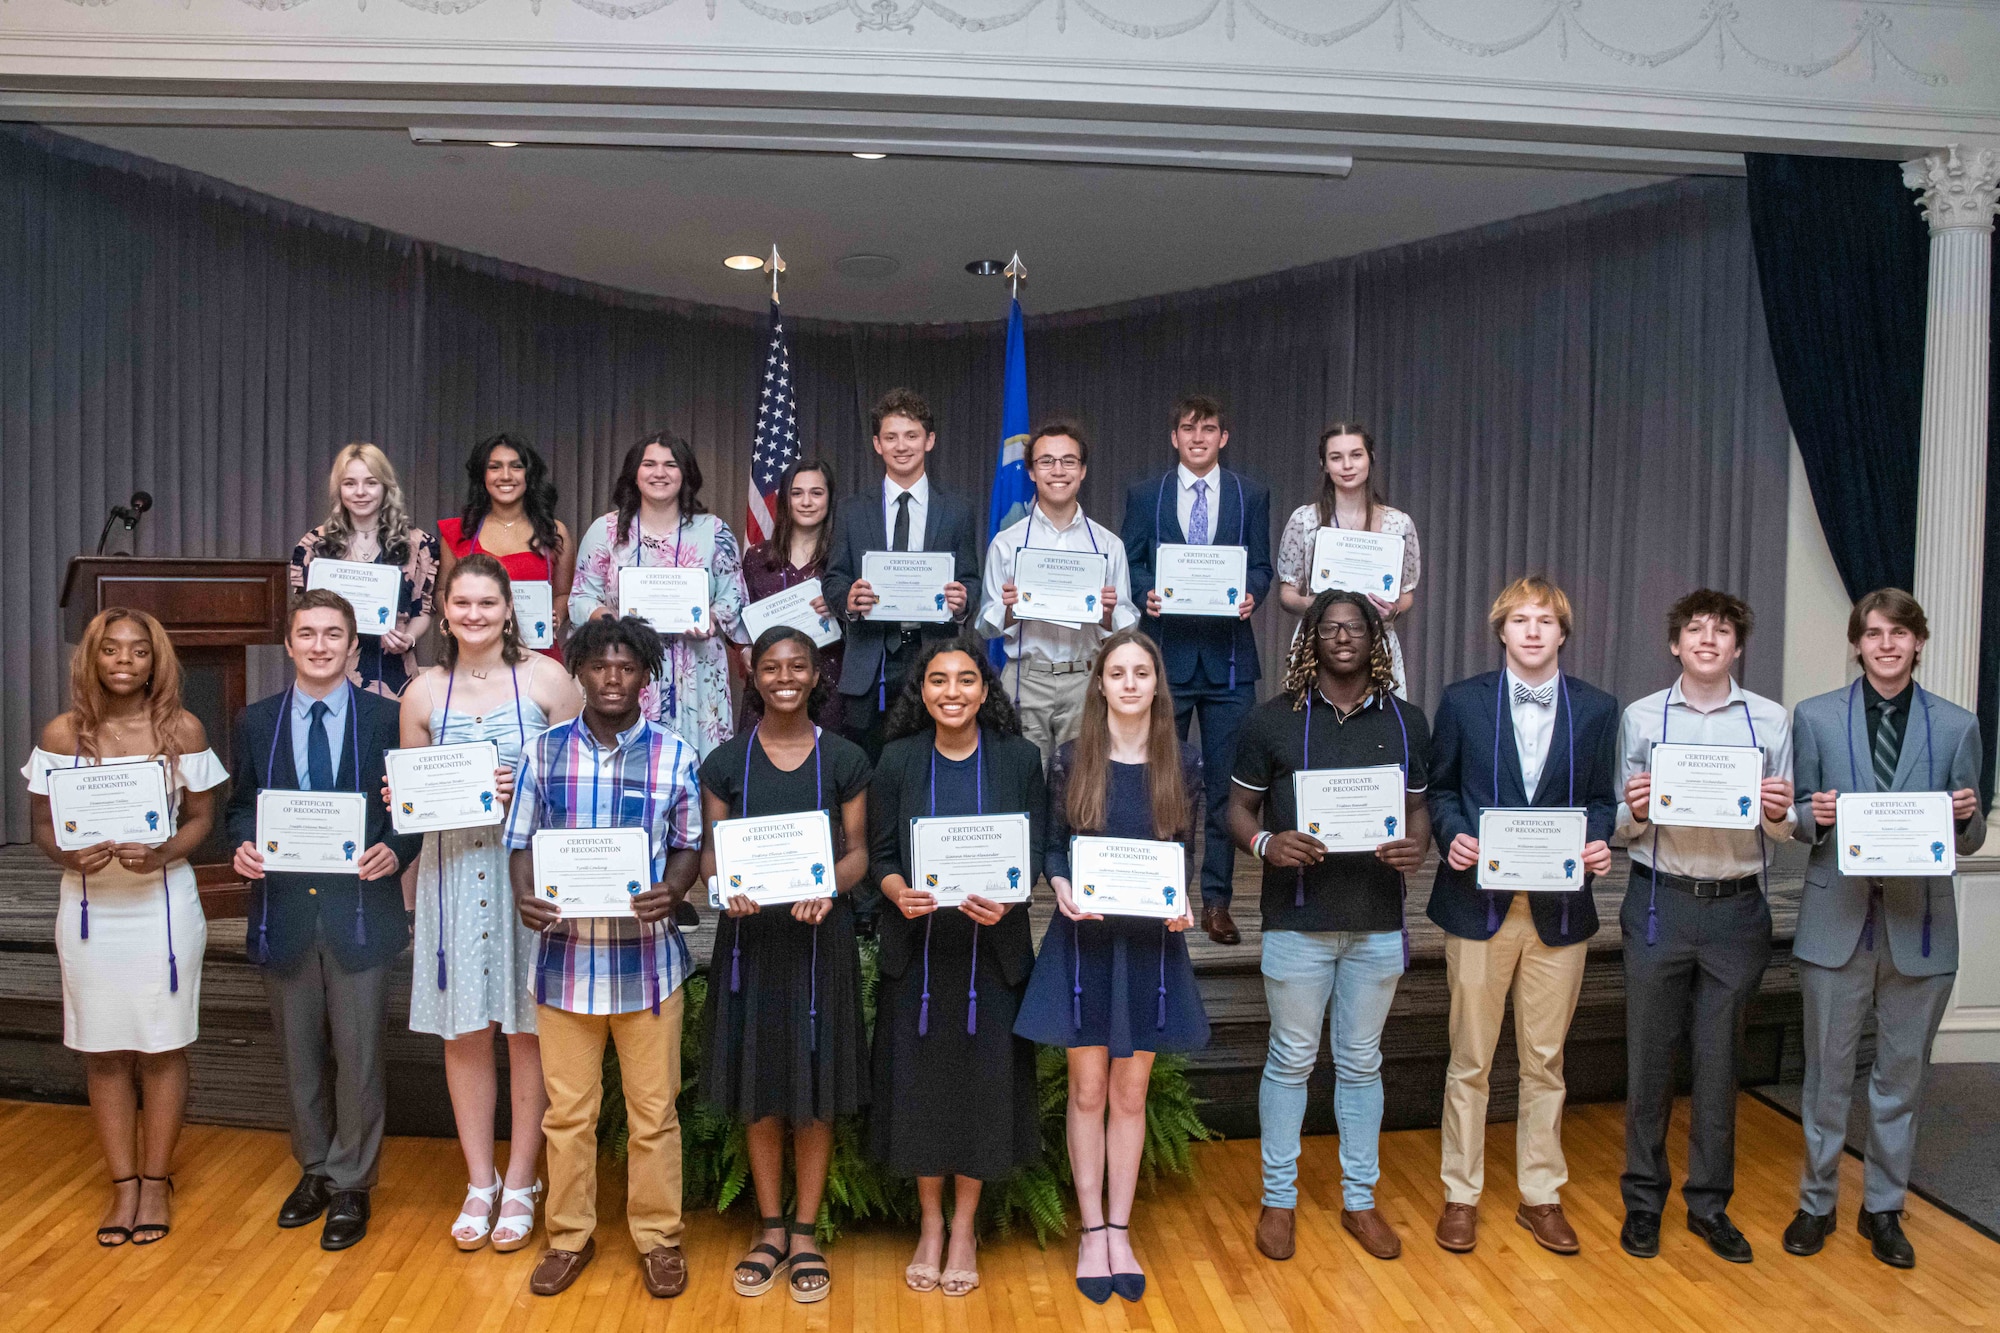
[[1428, 671, 1620, 947]]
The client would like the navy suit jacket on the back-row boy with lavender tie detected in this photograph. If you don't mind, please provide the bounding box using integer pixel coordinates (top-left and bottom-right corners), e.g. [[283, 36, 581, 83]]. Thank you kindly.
[[1120, 468, 1272, 689]]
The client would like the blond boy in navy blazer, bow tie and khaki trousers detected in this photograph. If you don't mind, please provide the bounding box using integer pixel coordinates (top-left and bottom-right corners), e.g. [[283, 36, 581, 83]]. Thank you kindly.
[[1430, 578, 1618, 1255]]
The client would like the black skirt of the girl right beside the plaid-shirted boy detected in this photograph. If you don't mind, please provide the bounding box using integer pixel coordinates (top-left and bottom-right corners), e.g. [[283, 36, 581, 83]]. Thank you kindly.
[[702, 895, 868, 1125]]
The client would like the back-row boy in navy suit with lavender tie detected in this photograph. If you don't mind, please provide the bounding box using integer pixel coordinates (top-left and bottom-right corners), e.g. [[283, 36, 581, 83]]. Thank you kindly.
[[1122, 396, 1272, 945]]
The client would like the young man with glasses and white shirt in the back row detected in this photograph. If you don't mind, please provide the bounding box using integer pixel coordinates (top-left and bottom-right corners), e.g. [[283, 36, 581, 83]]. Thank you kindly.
[[978, 420, 1138, 765]]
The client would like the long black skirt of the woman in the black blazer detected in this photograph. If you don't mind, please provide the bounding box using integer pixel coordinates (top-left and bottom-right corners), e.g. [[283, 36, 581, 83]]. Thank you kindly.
[[868, 907, 1042, 1181]]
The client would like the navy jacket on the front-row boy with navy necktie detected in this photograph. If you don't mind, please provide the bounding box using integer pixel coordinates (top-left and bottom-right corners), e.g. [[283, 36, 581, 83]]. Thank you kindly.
[[228, 691, 424, 973]]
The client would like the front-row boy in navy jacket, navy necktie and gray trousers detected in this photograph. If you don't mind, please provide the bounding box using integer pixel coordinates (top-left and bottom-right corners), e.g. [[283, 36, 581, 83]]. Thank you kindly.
[[228, 588, 422, 1249]]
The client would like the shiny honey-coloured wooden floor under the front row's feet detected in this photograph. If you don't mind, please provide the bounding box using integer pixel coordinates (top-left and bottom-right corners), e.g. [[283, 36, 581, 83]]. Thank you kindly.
[[0, 1097, 2000, 1333]]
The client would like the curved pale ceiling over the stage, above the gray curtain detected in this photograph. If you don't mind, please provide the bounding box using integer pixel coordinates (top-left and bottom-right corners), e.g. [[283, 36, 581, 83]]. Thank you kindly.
[[54, 126, 1660, 322]]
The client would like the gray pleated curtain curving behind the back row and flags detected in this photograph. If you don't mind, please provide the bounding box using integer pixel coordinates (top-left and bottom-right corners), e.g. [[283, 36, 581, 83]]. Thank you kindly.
[[0, 128, 1786, 841]]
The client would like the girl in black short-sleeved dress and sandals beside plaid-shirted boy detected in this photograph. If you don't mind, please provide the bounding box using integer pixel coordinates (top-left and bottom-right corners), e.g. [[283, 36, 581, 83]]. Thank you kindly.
[[702, 624, 868, 1303]]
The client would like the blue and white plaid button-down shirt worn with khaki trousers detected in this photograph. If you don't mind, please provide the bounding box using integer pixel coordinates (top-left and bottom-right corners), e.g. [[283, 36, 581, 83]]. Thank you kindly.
[[506, 719, 702, 1013]]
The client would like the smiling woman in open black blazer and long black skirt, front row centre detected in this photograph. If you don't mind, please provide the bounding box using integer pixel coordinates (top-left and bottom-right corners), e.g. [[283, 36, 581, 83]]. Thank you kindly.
[[868, 638, 1048, 1295]]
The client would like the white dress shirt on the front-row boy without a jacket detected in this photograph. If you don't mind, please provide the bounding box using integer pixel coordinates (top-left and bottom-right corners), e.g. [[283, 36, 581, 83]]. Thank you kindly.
[[1616, 679, 1798, 879]]
